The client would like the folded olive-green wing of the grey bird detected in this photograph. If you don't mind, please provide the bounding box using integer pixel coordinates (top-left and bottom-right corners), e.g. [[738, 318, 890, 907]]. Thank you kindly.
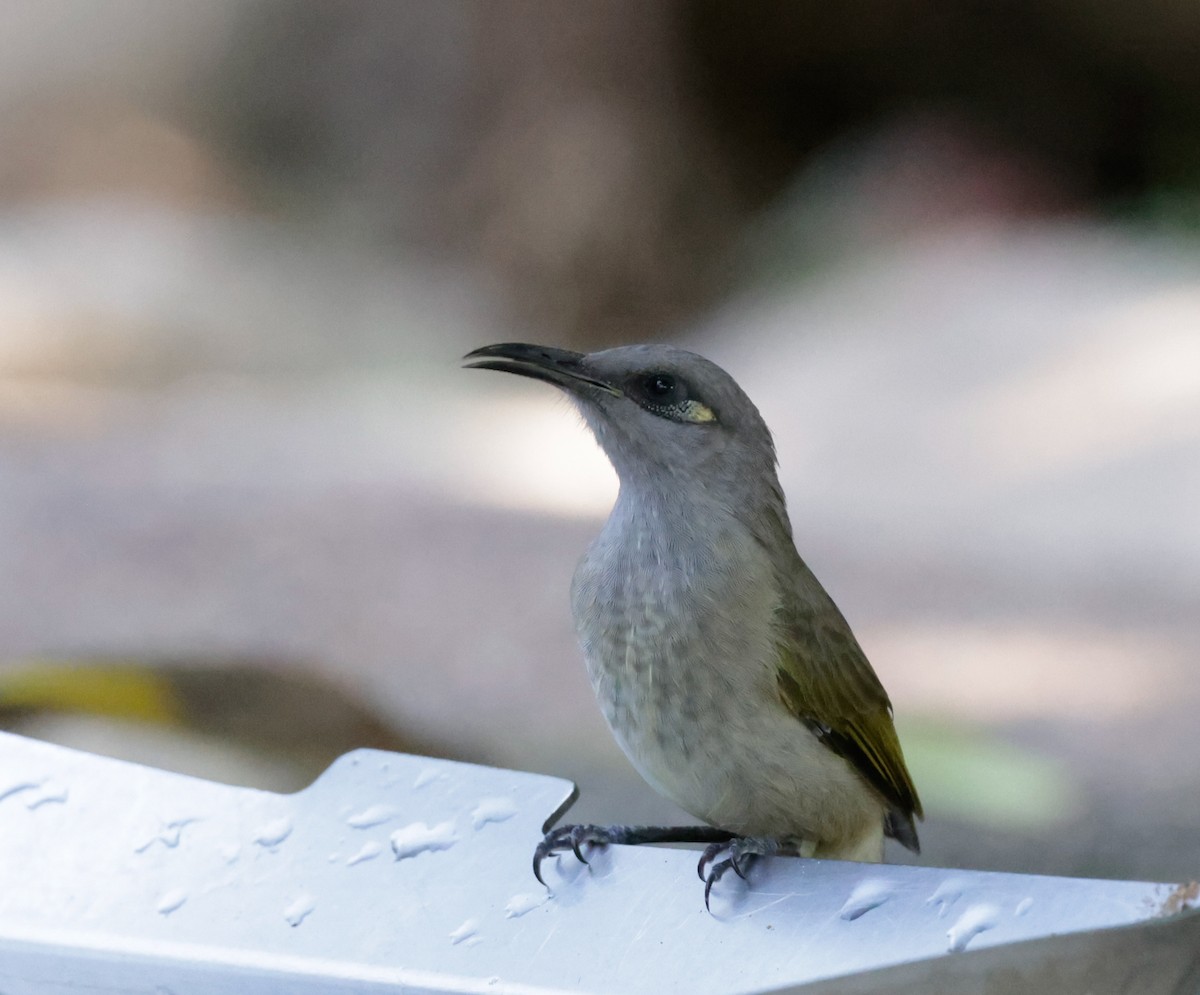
[[778, 567, 924, 851]]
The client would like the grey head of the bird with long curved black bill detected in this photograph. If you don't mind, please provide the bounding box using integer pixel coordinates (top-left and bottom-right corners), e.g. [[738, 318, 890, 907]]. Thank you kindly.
[[464, 342, 778, 502]]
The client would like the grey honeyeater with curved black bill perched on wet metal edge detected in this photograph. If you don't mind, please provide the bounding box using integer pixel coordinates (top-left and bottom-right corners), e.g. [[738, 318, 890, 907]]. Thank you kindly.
[[463, 342, 924, 906]]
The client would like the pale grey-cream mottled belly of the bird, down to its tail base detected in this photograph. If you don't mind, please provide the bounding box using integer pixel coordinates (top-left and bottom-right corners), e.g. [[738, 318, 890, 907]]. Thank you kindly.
[[571, 604, 883, 856]]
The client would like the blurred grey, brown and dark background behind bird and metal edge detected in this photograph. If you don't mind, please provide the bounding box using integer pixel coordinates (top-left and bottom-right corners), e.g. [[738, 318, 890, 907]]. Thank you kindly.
[[0, 0, 1200, 881]]
